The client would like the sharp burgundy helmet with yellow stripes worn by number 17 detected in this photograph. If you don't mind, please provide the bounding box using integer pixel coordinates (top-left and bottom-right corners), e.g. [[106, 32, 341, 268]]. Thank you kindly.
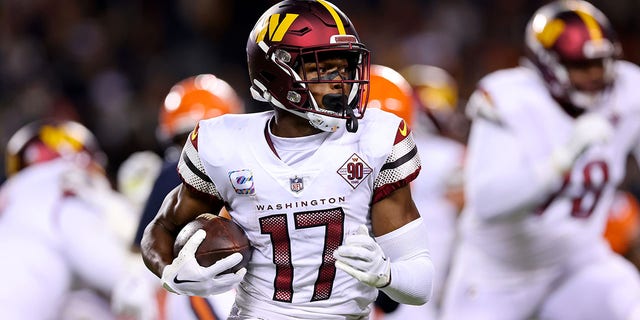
[[247, 0, 370, 132]]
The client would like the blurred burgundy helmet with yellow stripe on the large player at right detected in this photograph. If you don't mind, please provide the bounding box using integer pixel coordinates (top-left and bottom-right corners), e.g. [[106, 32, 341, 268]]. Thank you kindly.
[[525, 0, 622, 108]]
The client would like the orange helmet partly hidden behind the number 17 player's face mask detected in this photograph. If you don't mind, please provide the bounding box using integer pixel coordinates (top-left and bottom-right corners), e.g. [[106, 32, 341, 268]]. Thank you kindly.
[[368, 64, 414, 125]]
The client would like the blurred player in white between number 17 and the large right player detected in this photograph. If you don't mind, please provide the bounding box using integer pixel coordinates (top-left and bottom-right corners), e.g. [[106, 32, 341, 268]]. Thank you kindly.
[[400, 65, 469, 319]]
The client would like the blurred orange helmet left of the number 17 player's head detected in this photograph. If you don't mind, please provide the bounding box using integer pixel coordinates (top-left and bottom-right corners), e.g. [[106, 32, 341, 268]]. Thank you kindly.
[[158, 74, 244, 141]]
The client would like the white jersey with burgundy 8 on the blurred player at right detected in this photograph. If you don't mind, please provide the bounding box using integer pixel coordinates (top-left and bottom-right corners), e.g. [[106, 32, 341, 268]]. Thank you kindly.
[[462, 61, 640, 270]]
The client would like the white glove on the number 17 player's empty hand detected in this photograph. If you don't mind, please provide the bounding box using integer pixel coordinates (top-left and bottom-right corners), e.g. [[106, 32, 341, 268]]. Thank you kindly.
[[333, 225, 391, 288]]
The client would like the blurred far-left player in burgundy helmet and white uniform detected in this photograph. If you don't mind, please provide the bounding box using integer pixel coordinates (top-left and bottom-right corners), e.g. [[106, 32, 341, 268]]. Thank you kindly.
[[0, 120, 132, 319]]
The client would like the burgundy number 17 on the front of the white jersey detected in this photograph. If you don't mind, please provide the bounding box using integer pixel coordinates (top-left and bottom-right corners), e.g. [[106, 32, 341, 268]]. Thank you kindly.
[[260, 208, 344, 302]]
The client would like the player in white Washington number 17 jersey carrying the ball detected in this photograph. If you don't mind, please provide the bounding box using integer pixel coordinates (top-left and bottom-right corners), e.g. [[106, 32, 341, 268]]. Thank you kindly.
[[142, 0, 433, 319]]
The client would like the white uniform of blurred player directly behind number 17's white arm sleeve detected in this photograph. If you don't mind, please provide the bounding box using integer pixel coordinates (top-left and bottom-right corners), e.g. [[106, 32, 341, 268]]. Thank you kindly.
[[384, 128, 465, 320]]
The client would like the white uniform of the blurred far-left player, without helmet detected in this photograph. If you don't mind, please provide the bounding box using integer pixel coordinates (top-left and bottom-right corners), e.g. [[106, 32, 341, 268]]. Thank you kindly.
[[0, 159, 131, 319]]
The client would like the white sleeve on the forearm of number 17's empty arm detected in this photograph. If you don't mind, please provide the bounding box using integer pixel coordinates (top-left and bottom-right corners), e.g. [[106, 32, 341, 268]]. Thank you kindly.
[[376, 218, 434, 305]]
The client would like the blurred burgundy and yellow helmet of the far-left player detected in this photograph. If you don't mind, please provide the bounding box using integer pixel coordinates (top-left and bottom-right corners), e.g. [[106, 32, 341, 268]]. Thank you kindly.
[[5, 119, 107, 177]]
